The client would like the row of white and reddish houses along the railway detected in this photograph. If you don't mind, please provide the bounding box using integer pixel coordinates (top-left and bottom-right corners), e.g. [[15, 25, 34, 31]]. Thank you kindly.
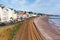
[[0, 4, 36, 23]]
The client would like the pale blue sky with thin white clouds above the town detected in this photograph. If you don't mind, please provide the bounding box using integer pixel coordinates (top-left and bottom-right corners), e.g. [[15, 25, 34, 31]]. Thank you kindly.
[[0, 0, 60, 15]]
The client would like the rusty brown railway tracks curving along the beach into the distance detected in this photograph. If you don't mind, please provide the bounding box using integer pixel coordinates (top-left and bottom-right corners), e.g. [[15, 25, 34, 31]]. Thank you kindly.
[[13, 18, 43, 40]]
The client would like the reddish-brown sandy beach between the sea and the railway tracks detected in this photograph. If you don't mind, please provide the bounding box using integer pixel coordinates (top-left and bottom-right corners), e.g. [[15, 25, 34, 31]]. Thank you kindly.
[[34, 17, 60, 40]]
